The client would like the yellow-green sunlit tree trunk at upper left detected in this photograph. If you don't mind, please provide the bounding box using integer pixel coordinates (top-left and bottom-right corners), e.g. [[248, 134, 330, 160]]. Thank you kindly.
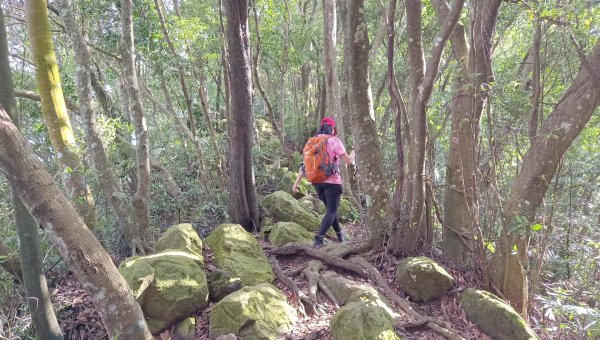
[[25, 0, 97, 229]]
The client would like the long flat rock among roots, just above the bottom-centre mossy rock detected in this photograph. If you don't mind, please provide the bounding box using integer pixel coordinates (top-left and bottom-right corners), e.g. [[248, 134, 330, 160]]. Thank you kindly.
[[319, 271, 399, 319]]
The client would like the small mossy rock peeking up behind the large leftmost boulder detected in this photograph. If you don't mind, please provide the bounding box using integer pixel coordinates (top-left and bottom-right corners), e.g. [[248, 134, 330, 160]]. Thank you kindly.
[[154, 223, 204, 259]]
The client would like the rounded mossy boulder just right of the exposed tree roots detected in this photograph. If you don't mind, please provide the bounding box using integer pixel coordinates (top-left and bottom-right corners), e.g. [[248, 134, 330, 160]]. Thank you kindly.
[[396, 256, 455, 301]]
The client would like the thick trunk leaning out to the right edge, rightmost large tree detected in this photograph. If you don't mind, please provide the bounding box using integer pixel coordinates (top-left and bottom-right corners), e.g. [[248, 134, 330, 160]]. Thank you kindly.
[[492, 42, 600, 315]]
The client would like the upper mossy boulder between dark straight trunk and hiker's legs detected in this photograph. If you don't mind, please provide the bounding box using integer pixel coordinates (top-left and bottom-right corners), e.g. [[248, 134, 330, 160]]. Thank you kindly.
[[262, 191, 321, 231]]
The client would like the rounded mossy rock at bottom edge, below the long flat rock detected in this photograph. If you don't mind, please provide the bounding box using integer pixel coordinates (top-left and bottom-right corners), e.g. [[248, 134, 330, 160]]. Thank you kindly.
[[331, 302, 400, 340]]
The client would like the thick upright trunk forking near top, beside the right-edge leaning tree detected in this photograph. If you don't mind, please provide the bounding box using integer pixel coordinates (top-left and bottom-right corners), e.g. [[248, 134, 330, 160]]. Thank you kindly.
[[432, 0, 501, 265]]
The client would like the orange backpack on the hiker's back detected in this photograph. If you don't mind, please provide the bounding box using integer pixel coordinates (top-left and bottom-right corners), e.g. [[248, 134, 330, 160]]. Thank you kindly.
[[302, 135, 333, 184]]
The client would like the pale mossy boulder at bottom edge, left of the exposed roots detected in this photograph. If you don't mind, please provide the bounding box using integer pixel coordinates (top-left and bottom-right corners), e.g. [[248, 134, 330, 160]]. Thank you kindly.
[[209, 283, 297, 339]]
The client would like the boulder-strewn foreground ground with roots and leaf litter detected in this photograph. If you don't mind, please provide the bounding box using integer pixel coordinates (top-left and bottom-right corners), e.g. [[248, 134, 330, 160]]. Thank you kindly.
[[49, 192, 536, 340]]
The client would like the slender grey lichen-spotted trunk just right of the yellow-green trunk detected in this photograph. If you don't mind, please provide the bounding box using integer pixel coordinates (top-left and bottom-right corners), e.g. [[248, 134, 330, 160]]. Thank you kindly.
[[58, 0, 137, 255]]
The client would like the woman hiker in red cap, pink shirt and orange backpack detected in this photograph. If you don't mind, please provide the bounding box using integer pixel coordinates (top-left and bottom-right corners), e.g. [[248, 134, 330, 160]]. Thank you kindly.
[[292, 117, 354, 247]]
